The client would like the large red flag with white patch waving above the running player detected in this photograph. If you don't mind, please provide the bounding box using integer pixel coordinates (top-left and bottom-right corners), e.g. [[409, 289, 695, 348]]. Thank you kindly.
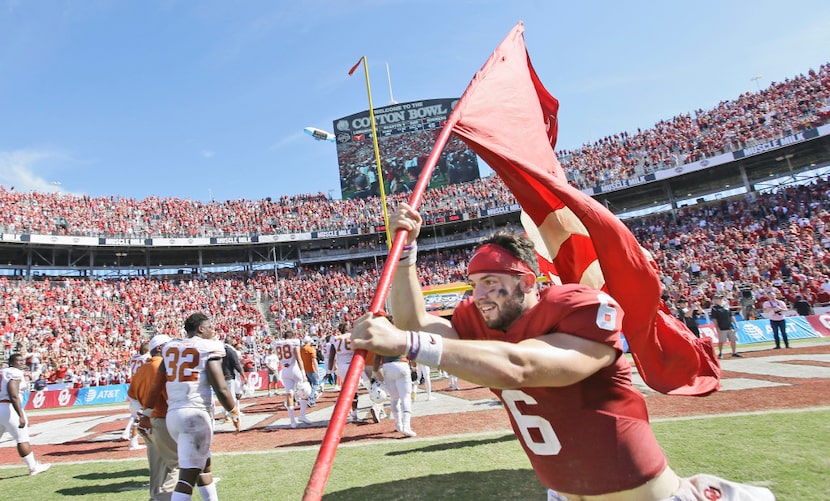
[[453, 23, 720, 395]]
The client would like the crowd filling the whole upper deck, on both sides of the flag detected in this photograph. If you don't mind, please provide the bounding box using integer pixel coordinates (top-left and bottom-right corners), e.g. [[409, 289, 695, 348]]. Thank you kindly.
[[0, 63, 830, 238]]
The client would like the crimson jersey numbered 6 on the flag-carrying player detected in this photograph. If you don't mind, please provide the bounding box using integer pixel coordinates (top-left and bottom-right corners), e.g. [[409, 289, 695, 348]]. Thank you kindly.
[[452, 284, 668, 495]]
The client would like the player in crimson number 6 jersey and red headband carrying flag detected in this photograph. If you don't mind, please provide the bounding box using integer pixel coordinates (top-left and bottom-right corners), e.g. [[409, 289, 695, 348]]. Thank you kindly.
[[351, 204, 774, 501]]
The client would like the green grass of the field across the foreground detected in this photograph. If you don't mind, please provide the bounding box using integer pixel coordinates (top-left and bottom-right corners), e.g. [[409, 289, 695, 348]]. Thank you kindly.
[[0, 410, 830, 501]]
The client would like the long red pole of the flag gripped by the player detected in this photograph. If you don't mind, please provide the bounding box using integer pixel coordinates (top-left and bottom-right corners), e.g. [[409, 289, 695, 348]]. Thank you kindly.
[[303, 111, 464, 501]]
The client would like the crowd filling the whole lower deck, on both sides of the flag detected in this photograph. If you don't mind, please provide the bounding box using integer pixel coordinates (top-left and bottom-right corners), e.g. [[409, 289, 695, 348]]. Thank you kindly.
[[0, 174, 830, 386]]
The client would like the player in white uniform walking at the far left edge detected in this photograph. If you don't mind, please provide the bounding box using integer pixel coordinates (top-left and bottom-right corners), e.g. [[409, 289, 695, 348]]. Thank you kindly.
[[0, 353, 52, 475]]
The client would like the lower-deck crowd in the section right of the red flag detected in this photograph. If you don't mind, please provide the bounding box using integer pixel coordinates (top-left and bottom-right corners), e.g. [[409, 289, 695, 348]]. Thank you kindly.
[[628, 179, 830, 307]]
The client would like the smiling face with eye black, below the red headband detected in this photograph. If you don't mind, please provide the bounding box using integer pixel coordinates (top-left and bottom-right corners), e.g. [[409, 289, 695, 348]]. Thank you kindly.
[[470, 273, 525, 330]]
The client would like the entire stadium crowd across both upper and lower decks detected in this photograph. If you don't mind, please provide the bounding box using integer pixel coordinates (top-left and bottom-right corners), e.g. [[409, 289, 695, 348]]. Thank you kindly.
[[0, 65, 830, 386]]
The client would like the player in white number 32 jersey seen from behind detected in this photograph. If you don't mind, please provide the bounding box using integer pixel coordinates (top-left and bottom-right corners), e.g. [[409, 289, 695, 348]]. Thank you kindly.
[[159, 313, 240, 501]]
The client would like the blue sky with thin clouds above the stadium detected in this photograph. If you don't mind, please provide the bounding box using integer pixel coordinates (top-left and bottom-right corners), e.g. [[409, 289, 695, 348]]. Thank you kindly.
[[0, 0, 830, 200]]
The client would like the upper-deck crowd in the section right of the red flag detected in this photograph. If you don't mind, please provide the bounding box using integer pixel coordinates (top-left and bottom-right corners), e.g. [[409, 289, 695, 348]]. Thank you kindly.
[[558, 63, 830, 188]]
